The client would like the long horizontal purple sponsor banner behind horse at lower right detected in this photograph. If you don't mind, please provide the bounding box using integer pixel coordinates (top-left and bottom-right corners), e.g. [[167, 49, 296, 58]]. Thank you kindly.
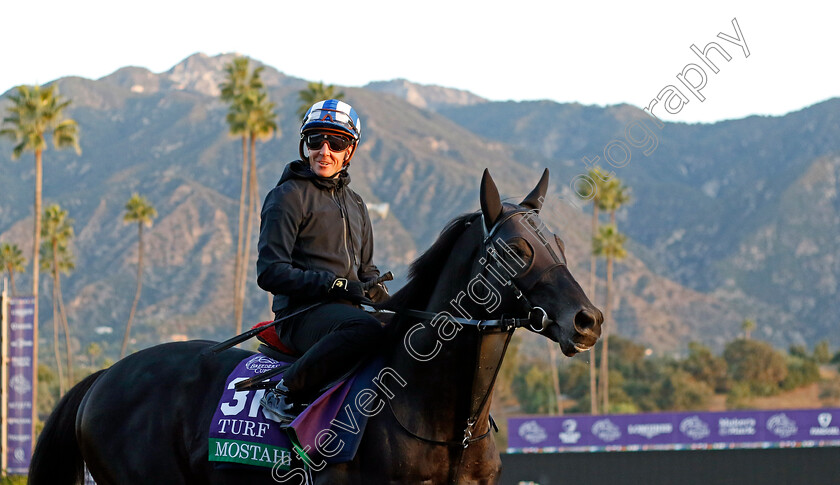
[[508, 408, 840, 452]]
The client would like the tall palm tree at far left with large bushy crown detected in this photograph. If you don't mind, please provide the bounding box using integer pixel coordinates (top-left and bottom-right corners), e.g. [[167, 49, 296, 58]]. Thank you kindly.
[[0, 85, 82, 412]]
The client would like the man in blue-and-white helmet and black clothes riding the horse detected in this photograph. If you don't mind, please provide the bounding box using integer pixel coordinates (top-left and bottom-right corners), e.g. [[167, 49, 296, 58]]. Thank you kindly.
[[257, 99, 387, 422]]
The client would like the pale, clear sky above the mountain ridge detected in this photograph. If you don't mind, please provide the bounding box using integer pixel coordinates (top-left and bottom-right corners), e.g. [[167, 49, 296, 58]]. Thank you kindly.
[[0, 0, 840, 122]]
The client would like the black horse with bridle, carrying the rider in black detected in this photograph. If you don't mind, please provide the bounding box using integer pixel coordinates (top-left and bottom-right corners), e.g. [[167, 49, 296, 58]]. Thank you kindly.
[[29, 170, 603, 485]]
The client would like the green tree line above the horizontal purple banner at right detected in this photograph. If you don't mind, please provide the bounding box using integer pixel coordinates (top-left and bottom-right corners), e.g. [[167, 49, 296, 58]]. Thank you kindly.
[[500, 328, 840, 414]]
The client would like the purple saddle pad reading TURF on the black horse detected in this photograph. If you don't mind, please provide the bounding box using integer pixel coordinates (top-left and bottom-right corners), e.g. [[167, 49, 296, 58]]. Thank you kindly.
[[208, 354, 381, 470]]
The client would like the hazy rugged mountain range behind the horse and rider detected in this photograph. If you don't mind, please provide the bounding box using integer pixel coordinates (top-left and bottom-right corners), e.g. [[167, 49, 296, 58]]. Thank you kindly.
[[0, 54, 840, 354]]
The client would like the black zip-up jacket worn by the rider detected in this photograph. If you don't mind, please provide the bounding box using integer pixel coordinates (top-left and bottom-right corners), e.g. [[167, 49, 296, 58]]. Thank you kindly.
[[257, 160, 379, 313]]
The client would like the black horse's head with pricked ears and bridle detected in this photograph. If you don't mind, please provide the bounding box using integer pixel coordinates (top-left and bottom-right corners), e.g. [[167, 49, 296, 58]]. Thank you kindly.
[[481, 169, 604, 356]]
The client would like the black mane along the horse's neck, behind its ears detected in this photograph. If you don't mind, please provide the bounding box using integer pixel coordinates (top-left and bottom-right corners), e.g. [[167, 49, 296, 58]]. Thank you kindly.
[[386, 212, 479, 309]]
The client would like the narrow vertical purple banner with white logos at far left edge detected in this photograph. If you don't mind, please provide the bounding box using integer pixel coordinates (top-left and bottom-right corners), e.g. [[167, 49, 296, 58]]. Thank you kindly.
[[6, 297, 35, 474]]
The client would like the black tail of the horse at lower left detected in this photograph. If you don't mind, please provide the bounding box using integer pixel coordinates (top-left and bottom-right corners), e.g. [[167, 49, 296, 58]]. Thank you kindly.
[[28, 370, 105, 485]]
